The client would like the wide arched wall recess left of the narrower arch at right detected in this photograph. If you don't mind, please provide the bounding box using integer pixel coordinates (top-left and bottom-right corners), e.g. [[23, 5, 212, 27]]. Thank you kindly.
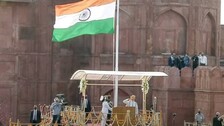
[[153, 10, 186, 54]]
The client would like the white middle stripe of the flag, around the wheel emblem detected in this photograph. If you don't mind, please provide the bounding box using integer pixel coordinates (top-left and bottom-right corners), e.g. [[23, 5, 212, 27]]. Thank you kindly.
[[54, 2, 115, 28]]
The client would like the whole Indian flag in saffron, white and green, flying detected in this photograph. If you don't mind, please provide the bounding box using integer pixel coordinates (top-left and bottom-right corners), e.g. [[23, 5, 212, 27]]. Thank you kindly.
[[52, 0, 115, 42]]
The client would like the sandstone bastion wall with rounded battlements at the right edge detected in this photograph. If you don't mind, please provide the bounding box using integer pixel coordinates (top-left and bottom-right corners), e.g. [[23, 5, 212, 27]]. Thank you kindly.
[[195, 67, 224, 122]]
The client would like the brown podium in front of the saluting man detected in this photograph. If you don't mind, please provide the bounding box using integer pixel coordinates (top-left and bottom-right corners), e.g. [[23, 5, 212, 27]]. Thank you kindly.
[[112, 106, 135, 126]]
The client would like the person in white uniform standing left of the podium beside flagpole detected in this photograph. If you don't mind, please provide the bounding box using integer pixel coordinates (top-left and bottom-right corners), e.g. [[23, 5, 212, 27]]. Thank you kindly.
[[101, 98, 112, 126]]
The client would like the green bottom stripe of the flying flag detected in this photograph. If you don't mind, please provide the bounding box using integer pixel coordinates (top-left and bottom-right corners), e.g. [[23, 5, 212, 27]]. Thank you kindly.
[[52, 18, 114, 42]]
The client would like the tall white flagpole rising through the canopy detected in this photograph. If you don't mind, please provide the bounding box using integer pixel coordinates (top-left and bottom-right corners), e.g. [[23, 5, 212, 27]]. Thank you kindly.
[[114, 0, 120, 107]]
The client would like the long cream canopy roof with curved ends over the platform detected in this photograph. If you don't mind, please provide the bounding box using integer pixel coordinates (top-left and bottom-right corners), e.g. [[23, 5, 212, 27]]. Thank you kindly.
[[70, 70, 168, 81]]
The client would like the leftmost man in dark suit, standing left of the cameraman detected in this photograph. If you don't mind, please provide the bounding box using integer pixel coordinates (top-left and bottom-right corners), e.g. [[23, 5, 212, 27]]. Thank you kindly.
[[30, 105, 41, 126]]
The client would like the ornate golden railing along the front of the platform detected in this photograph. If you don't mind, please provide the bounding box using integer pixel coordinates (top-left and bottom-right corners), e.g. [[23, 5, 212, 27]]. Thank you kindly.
[[9, 106, 162, 126]]
